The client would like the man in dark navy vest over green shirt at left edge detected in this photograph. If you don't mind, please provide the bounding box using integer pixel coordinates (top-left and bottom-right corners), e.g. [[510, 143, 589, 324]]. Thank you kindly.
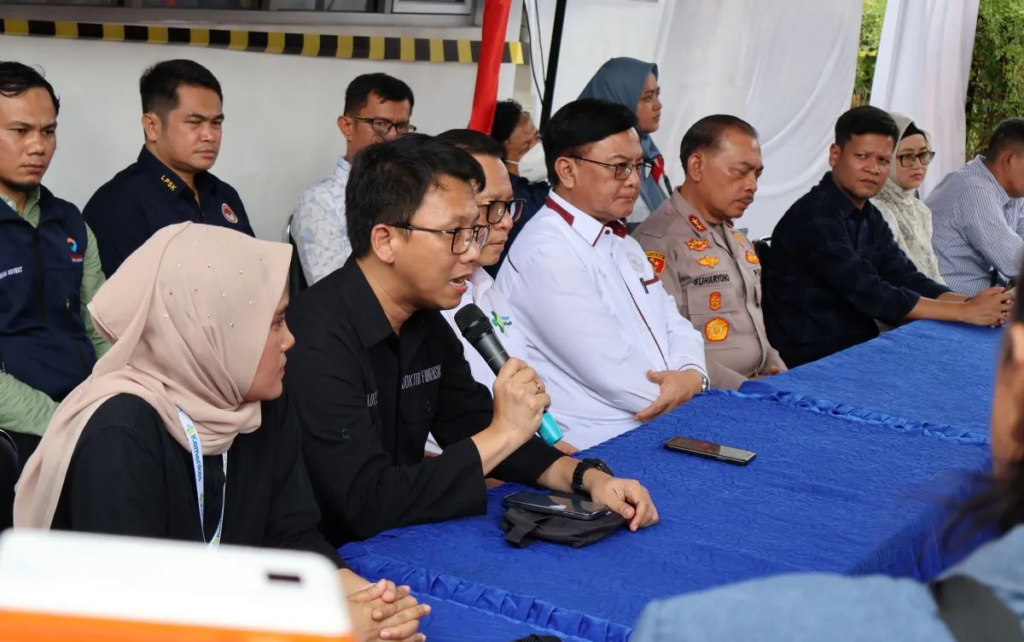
[[0, 62, 110, 464]]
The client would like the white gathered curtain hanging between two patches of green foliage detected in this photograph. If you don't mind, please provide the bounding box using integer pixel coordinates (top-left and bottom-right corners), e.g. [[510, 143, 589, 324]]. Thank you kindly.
[[871, 0, 978, 196]]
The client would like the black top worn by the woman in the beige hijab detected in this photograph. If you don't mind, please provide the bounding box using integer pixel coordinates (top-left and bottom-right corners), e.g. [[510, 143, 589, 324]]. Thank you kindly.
[[52, 394, 345, 568]]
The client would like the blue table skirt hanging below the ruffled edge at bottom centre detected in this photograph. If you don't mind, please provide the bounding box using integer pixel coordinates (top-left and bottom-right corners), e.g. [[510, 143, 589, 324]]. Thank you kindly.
[[420, 596, 585, 642]]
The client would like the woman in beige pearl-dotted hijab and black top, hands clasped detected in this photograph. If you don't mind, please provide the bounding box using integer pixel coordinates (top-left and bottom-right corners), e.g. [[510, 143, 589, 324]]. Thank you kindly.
[[14, 223, 429, 640]]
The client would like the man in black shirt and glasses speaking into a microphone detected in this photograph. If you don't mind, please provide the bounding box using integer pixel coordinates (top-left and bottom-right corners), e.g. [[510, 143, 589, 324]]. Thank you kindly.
[[285, 134, 657, 546]]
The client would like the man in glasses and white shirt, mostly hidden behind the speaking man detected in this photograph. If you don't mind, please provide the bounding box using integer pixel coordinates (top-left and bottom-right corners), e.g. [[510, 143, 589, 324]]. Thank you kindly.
[[427, 129, 575, 455]]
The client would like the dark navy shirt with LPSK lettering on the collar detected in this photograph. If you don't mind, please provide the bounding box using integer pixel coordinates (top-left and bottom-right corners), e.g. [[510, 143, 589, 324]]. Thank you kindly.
[[82, 147, 256, 276]]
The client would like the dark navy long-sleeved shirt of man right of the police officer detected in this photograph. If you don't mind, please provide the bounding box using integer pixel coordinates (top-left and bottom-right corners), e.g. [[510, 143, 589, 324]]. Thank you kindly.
[[761, 172, 949, 368]]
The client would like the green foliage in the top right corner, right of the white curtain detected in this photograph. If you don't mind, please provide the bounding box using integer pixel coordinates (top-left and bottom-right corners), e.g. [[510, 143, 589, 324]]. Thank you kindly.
[[967, 0, 1024, 159]]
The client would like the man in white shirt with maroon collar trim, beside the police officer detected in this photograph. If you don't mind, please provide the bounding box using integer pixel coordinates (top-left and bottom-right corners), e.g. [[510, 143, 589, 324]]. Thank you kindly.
[[498, 99, 710, 448]]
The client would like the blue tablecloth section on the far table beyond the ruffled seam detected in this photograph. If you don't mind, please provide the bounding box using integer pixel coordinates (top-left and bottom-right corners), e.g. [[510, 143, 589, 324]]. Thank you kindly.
[[740, 322, 1001, 439]]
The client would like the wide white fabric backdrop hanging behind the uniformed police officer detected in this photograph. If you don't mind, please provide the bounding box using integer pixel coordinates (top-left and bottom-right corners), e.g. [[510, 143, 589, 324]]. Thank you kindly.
[[647, 0, 864, 238]]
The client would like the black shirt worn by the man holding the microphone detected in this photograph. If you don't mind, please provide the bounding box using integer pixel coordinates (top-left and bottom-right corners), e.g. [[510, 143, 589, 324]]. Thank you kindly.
[[285, 258, 561, 546]]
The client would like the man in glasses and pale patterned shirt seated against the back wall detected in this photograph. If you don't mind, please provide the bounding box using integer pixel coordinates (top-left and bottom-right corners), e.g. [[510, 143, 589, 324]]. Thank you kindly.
[[291, 74, 416, 286]]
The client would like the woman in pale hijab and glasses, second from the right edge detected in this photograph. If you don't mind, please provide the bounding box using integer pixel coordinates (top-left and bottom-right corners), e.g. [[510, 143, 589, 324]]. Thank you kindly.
[[871, 112, 945, 284]]
